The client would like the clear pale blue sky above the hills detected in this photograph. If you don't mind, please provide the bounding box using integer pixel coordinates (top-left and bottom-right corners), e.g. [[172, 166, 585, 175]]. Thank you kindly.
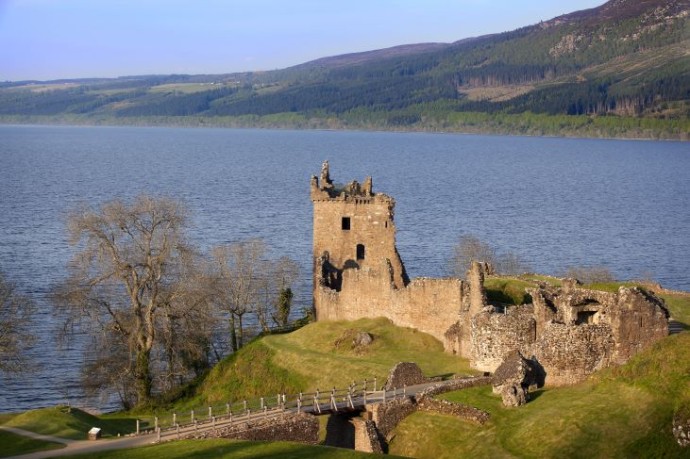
[[0, 0, 605, 81]]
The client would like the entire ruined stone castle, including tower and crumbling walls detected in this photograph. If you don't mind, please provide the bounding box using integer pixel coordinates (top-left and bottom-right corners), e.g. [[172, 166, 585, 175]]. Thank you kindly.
[[311, 162, 668, 385]]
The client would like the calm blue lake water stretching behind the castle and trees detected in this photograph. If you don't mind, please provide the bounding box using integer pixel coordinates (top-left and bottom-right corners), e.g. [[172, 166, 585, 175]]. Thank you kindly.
[[0, 126, 690, 411]]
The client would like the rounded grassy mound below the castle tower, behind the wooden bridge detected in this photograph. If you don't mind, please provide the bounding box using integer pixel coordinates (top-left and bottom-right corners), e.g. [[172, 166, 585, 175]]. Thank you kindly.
[[183, 318, 472, 408]]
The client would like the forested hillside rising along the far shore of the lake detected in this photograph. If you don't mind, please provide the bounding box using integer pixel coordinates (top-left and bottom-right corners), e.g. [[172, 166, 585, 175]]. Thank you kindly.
[[0, 0, 690, 139]]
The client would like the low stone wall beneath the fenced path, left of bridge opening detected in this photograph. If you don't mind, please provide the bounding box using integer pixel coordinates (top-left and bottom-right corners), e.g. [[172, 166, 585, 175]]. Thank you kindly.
[[184, 413, 319, 445]]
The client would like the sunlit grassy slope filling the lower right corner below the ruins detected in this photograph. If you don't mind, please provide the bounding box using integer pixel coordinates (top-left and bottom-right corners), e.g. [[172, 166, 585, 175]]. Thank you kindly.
[[390, 333, 690, 458]]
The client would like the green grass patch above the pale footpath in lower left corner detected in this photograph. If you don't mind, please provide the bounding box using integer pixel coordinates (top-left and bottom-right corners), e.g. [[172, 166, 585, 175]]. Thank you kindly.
[[4, 406, 136, 440]]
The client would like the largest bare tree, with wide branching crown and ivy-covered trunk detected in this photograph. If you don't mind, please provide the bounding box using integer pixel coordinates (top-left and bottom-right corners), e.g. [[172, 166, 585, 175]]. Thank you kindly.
[[54, 196, 214, 404]]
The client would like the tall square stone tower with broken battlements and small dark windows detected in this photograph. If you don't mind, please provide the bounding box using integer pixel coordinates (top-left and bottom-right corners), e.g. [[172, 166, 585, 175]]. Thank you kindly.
[[311, 161, 409, 298]]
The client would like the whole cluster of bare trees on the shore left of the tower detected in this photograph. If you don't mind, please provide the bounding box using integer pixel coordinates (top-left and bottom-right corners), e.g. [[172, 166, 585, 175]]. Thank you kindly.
[[33, 196, 298, 408]]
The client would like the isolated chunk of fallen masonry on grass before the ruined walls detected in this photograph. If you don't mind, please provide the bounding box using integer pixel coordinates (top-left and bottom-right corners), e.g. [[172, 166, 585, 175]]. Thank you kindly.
[[491, 351, 545, 406]]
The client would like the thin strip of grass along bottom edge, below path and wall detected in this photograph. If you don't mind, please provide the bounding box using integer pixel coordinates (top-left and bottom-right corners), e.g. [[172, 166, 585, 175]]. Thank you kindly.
[[57, 439, 392, 459]]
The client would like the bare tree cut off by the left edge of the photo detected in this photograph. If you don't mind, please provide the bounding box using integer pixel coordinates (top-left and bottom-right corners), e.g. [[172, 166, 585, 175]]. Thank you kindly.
[[0, 272, 35, 376]]
